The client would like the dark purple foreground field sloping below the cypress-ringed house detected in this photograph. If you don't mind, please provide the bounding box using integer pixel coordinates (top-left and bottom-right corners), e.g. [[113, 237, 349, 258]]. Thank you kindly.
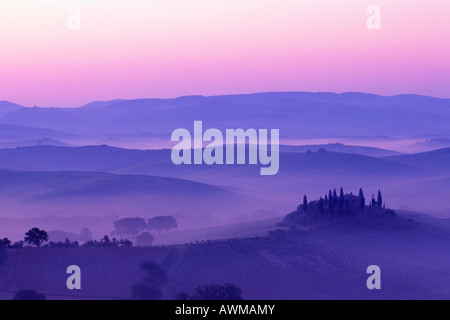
[[0, 213, 450, 299]]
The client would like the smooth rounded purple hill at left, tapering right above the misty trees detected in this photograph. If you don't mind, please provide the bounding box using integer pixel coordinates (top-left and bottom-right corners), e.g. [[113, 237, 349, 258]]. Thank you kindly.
[[0, 170, 266, 237]]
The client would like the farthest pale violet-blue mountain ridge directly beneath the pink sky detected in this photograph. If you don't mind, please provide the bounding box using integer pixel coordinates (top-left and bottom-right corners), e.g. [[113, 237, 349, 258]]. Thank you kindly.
[[0, 92, 450, 139]]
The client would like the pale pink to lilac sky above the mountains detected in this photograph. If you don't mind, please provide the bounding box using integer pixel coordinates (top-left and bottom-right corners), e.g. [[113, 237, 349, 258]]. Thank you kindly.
[[0, 0, 450, 107]]
